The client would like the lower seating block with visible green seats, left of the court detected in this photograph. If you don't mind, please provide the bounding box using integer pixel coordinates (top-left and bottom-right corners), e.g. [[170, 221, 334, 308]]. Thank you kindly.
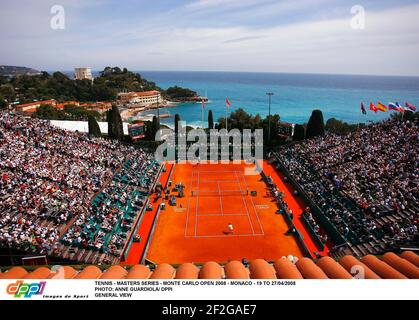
[[62, 158, 159, 257]]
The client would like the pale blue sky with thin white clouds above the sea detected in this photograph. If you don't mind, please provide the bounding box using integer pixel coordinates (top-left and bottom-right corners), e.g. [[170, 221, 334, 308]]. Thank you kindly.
[[0, 0, 419, 76]]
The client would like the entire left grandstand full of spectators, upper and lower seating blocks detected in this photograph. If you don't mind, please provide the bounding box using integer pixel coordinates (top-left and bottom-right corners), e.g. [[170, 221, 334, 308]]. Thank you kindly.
[[0, 114, 161, 263]]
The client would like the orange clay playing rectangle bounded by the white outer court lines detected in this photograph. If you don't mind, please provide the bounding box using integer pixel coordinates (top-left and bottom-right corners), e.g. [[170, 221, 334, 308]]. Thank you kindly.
[[185, 169, 264, 238]]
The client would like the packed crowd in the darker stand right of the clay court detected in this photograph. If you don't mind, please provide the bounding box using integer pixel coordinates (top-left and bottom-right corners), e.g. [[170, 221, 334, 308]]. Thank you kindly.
[[278, 119, 419, 250]]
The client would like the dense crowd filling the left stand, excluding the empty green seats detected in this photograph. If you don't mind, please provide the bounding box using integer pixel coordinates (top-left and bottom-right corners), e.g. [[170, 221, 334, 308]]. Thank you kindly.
[[0, 113, 161, 253]]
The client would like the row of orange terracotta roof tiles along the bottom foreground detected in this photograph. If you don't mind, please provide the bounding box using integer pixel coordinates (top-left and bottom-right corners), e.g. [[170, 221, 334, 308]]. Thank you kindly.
[[0, 252, 419, 279]]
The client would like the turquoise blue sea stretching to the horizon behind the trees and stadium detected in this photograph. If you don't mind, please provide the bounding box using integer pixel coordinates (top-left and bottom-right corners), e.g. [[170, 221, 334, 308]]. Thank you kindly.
[[139, 71, 419, 125]]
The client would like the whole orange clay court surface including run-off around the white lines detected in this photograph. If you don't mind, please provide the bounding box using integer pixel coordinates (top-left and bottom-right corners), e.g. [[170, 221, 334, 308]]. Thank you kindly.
[[146, 163, 303, 264]]
